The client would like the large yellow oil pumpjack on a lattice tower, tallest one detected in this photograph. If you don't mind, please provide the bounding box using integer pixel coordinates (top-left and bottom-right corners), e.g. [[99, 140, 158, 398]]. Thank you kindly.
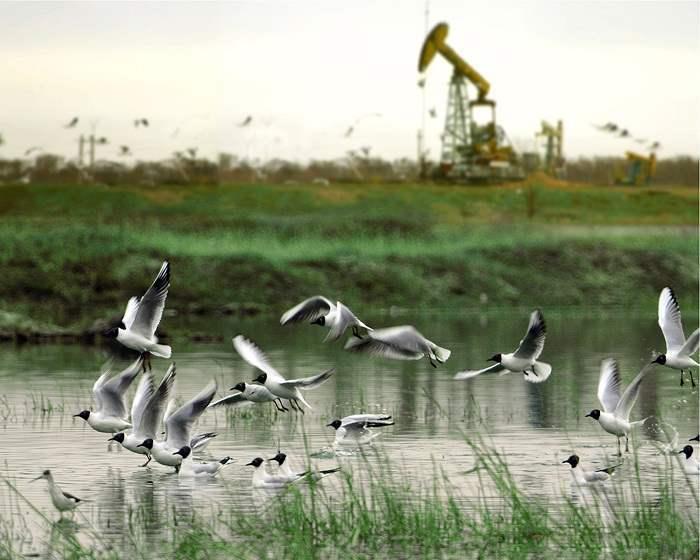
[[418, 23, 525, 183]]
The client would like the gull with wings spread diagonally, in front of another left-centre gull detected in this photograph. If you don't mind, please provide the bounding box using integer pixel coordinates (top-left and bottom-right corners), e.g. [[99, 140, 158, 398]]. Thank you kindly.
[[233, 334, 335, 414]]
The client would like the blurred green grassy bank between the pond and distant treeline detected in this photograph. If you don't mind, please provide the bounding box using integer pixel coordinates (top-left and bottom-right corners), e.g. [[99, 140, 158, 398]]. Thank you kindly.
[[0, 183, 698, 334]]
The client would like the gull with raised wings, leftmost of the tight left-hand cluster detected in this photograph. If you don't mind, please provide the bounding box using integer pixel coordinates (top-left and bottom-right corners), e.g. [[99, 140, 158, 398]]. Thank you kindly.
[[73, 357, 142, 434]]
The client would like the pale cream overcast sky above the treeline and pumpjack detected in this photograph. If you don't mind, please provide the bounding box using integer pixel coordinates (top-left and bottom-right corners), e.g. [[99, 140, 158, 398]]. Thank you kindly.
[[0, 0, 700, 161]]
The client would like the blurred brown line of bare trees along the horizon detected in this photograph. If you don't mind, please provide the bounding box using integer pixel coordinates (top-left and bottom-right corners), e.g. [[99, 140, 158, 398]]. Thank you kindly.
[[0, 150, 700, 186]]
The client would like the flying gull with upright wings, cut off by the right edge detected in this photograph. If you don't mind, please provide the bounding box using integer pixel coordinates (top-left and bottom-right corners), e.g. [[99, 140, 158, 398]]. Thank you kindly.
[[652, 287, 700, 387]]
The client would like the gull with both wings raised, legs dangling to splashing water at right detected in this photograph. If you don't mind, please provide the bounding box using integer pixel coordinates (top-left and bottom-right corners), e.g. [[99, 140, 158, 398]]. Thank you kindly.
[[586, 358, 652, 456]]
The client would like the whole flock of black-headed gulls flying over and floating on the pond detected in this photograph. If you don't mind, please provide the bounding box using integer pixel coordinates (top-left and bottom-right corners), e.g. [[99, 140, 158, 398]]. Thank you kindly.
[[30, 261, 700, 512]]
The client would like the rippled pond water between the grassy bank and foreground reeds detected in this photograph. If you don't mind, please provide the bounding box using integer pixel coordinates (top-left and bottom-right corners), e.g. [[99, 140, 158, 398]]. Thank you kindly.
[[0, 310, 698, 554]]
